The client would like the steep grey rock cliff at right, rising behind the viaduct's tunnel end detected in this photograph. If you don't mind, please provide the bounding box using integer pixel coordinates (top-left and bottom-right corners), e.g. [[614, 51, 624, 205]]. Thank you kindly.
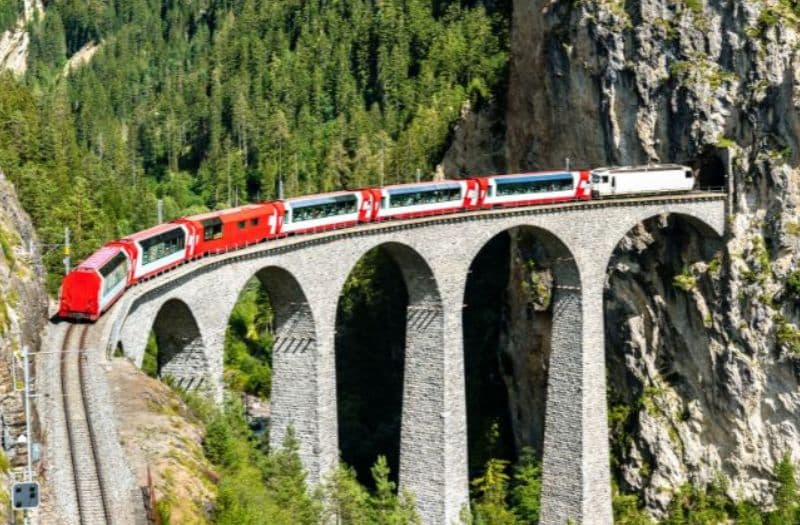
[[446, 0, 800, 516]]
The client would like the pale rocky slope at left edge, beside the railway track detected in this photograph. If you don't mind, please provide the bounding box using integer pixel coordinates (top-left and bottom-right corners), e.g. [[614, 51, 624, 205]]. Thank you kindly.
[[0, 172, 47, 484]]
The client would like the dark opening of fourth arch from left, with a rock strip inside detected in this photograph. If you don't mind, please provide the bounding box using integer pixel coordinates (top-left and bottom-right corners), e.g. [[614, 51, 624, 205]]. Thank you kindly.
[[463, 226, 581, 492]]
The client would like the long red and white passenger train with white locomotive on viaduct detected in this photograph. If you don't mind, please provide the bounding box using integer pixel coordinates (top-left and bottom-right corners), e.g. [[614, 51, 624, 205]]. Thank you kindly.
[[58, 164, 694, 321]]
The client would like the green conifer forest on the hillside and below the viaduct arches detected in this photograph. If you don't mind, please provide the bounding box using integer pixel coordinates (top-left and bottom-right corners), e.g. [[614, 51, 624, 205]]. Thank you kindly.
[[0, 0, 799, 524]]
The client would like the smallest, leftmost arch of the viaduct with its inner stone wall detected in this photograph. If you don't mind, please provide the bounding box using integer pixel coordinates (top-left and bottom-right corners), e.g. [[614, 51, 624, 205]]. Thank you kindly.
[[152, 299, 209, 390]]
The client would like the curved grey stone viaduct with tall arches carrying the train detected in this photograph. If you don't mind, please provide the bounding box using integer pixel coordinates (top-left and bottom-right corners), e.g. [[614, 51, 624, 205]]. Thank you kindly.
[[106, 193, 725, 524]]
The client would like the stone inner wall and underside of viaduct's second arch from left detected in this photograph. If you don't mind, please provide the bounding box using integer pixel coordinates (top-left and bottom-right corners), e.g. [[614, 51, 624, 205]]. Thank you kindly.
[[226, 266, 318, 454]]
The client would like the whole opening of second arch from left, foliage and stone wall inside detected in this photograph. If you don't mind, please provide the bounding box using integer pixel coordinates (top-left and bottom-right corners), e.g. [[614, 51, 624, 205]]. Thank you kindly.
[[223, 266, 317, 454]]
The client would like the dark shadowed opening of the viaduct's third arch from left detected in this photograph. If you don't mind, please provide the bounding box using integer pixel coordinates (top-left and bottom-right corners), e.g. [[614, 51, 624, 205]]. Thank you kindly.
[[335, 245, 412, 488]]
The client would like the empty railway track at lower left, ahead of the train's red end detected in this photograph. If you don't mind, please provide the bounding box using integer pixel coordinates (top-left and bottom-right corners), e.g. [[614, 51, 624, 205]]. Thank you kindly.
[[60, 324, 112, 525]]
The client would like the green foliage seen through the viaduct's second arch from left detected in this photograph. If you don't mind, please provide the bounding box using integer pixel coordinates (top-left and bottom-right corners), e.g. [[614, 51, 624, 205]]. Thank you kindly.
[[224, 277, 273, 399]]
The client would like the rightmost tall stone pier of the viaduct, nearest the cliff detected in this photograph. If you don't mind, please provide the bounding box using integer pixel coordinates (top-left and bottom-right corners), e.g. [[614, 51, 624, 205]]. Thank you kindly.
[[539, 268, 613, 525]]
